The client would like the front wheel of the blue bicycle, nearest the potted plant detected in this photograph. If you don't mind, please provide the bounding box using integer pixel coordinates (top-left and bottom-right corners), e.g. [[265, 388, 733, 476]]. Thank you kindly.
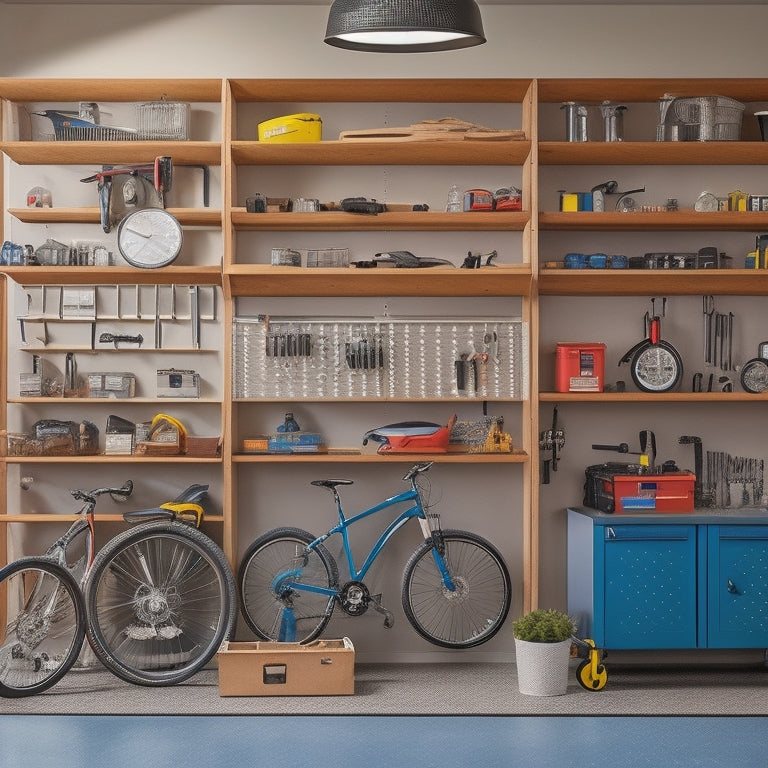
[[402, 531, 512, 648]]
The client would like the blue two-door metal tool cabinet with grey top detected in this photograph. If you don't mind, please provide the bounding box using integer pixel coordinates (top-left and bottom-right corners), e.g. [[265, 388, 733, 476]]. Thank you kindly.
[[567, 508, 768, 650]]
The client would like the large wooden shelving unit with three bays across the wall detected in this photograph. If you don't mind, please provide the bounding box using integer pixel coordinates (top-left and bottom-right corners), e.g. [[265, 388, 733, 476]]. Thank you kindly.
[[0, 78, 768, 656]]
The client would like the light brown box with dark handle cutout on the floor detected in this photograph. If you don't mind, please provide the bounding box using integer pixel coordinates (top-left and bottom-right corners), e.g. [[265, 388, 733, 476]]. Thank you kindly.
[[217, 637, 355, 696]]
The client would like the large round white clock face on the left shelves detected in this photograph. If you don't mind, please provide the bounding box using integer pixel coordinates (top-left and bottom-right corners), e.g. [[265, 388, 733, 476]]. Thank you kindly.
[[117, 208, 182, 269]]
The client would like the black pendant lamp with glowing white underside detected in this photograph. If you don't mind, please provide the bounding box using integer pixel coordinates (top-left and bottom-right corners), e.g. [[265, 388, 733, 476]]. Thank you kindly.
[[325, 0, 485, 53]]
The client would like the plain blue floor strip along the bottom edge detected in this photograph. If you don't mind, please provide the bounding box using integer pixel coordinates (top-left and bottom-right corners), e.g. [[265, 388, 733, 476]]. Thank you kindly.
[[0, 715, 768, 768]]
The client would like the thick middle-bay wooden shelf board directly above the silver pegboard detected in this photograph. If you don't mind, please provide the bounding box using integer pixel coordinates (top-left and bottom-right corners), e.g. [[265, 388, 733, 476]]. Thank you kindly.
[[225, 265, 531, 296]]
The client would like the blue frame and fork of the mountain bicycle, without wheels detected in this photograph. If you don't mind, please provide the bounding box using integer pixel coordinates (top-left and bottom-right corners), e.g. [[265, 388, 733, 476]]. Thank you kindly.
[[272, 478, 455, 597]]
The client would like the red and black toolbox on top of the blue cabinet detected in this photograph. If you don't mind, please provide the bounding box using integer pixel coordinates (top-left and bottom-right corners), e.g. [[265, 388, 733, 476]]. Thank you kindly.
[[584, 464, 696, 514]]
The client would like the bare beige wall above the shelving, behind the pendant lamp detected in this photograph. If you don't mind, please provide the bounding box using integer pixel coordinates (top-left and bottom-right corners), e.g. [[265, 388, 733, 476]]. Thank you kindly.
[[0, 2, 768, 77]]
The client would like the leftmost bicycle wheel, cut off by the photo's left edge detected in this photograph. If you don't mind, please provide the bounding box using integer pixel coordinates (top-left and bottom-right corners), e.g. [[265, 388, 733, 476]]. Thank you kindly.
[[0, 557, 85, 698]]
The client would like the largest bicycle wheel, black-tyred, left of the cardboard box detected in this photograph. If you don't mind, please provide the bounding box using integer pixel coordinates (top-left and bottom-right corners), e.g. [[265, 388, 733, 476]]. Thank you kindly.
[[85, 521, 237, 686]]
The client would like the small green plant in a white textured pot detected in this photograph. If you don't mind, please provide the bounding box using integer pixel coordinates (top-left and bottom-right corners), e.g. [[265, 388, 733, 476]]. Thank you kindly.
[[512, 608, 576, 696]]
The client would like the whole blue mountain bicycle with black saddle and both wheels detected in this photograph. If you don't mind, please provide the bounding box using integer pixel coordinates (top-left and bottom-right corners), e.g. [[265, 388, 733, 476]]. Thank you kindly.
[[238, 462, 511, 648]]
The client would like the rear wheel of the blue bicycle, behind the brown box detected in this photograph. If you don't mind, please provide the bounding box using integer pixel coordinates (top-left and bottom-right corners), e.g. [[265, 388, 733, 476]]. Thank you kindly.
[[237, 528, 339, 643]]
